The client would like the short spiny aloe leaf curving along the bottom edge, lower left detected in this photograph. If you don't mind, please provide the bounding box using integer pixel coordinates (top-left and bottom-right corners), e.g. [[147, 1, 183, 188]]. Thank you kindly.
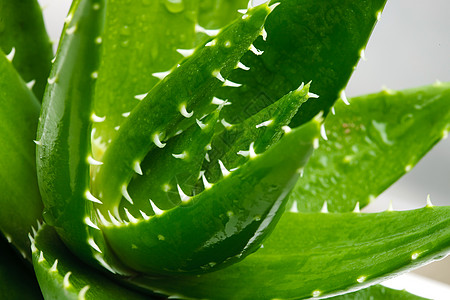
[[32, 225, 151, 300]]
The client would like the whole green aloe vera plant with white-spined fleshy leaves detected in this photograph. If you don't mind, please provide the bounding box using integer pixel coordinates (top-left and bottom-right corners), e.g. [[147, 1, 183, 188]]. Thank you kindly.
[[0, 0, 450, 299]]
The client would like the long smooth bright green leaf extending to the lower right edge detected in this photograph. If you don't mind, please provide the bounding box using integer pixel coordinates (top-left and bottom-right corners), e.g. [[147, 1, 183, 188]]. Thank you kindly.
[[135, 207, 450, 299]]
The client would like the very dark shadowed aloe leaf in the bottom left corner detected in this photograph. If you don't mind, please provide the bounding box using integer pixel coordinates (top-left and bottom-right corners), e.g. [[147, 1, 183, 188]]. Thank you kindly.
[[0, 236, 42, 300]]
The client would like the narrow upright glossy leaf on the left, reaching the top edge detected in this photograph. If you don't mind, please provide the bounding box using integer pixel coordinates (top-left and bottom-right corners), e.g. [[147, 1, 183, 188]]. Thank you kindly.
[[37, 0, 127, 271]]
